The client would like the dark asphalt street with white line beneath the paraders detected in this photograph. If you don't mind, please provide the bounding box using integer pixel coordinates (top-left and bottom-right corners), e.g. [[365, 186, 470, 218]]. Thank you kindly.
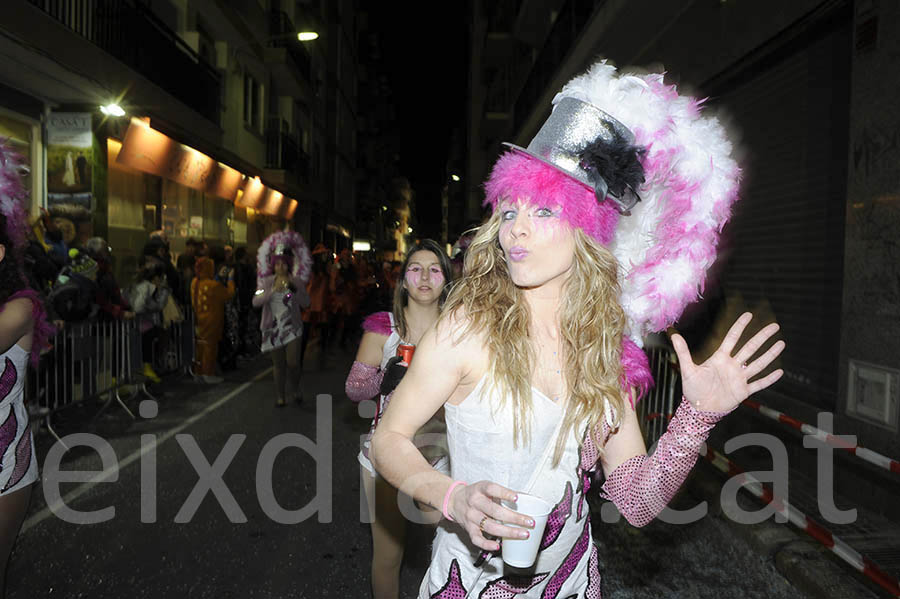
[[7, 344, 803, 599]]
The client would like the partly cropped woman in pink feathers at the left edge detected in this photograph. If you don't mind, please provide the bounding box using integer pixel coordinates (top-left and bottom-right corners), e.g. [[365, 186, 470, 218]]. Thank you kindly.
[[0, 140, 54, 596]]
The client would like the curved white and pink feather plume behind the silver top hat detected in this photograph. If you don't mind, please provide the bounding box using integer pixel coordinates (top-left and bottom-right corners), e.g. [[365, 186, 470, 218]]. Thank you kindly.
[[553, 61, 740, 344]]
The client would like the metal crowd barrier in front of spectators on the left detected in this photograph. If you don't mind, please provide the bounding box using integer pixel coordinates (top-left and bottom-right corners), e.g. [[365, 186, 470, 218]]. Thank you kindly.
[[26, 317, 194, 442]]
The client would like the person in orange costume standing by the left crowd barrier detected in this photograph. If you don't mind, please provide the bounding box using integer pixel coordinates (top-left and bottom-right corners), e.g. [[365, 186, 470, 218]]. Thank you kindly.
[[191, 257, 234, 383]]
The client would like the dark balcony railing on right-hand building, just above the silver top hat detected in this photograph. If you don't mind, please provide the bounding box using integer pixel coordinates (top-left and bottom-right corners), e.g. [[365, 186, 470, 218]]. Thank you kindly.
[[514, 0, 606, 131]]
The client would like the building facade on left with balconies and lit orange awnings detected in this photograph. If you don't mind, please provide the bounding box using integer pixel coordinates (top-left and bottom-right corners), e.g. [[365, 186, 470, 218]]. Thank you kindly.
[[0, 0, 355, 280]]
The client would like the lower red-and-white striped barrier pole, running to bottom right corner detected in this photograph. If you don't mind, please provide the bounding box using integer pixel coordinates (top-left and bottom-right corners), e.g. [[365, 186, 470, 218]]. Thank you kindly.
[[700, 442, 900, 597]]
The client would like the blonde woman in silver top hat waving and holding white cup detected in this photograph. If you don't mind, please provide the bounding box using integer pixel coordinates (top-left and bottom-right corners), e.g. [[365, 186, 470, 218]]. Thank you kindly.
[[371, 62, 784, 598]]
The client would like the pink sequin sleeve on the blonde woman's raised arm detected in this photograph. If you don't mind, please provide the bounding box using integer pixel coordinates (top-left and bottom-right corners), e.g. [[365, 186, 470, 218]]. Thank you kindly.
[[600, 399, 728, 526]]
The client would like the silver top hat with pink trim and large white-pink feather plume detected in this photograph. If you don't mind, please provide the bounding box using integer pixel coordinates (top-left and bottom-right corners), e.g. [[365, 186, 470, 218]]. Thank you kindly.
[[485, 61, 741, 344]]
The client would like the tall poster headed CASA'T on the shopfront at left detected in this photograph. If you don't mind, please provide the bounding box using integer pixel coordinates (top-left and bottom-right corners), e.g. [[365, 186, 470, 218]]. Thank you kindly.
[[47, 112, 94, 210]]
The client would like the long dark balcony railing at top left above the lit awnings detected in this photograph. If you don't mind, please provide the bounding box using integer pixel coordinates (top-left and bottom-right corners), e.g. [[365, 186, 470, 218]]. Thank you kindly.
[[29, 0, 221, 123]]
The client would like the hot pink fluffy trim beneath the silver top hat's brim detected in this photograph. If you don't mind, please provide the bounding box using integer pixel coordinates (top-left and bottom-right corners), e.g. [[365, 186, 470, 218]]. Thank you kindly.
[[484, 150, 619, 245]]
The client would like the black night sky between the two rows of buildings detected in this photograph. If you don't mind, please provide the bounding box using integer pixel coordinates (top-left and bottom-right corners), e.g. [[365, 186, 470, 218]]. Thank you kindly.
[[363, 0, 468, 237]]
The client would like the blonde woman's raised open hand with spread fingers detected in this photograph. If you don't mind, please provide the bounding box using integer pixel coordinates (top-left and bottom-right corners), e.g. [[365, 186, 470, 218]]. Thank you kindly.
[[672, 312, 784, 412]]
